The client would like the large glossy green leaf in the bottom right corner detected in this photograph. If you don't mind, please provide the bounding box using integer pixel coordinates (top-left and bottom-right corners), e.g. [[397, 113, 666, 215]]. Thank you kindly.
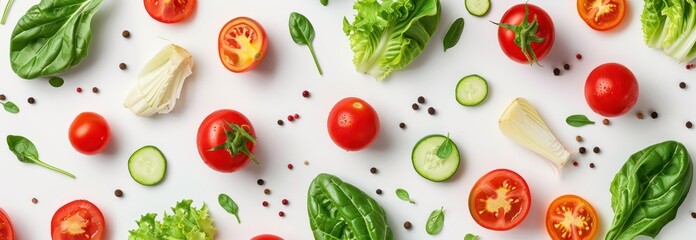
[[605, 141, 694, 240]]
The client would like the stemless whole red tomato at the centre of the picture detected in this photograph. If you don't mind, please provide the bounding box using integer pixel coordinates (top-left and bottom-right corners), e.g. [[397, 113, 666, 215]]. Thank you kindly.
[[327, 97, 379, 151]]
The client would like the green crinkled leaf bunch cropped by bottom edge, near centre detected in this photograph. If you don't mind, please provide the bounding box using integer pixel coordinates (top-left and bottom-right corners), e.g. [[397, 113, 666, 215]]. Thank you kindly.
[[307, 173, 394, 240]]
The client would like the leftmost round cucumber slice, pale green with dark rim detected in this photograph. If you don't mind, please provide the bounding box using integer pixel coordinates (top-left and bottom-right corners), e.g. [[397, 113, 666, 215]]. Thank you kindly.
[[128, 145, 167, 186]]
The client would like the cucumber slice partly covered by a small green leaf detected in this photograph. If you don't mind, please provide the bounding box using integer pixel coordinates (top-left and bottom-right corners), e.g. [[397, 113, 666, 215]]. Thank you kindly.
[[411, 134, 460, 182]]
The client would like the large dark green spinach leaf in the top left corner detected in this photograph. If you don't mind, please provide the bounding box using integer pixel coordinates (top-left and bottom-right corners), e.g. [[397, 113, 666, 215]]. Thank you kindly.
[[10, 0, 102, 79]]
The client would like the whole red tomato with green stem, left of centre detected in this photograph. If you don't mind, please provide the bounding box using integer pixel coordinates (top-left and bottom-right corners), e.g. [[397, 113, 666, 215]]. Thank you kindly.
[[196, 109, 256, 172]]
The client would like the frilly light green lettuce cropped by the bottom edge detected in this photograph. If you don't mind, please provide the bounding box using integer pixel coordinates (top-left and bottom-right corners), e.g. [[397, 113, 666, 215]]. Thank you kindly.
[[128, 199, 217, 240]]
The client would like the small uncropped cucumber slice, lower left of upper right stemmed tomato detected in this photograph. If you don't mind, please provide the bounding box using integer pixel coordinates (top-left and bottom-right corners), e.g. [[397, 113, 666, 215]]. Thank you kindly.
[[454, 74, 488, 107]]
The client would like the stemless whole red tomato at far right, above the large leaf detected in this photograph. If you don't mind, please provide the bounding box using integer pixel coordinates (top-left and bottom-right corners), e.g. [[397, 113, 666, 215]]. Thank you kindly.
[[585, 63, 638, 117]]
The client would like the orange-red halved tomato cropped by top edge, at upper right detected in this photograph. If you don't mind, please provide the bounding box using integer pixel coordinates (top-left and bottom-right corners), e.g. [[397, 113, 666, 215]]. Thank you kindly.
[[577, 0, 626, 31]]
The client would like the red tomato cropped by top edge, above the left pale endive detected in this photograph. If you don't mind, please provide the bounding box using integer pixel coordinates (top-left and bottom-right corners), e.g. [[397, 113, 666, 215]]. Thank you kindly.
[[144, 0, 196, 23]]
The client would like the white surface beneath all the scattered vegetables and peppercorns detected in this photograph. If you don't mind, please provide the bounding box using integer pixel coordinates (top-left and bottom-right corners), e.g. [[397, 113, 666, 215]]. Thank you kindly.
[[0, 0, 696, 239]]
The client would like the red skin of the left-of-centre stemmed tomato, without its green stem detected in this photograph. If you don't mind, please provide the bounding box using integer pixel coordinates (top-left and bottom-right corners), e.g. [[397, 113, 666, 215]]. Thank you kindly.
[[196, 109, 256, 172]]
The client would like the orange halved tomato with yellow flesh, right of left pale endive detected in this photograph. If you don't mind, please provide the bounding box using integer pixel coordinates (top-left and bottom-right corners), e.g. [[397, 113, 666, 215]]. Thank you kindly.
[[218, 17, 268, 73]]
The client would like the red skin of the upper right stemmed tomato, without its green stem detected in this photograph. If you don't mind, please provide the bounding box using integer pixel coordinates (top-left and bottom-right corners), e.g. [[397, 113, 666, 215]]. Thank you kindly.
[[498, 3, 556, 64]]
